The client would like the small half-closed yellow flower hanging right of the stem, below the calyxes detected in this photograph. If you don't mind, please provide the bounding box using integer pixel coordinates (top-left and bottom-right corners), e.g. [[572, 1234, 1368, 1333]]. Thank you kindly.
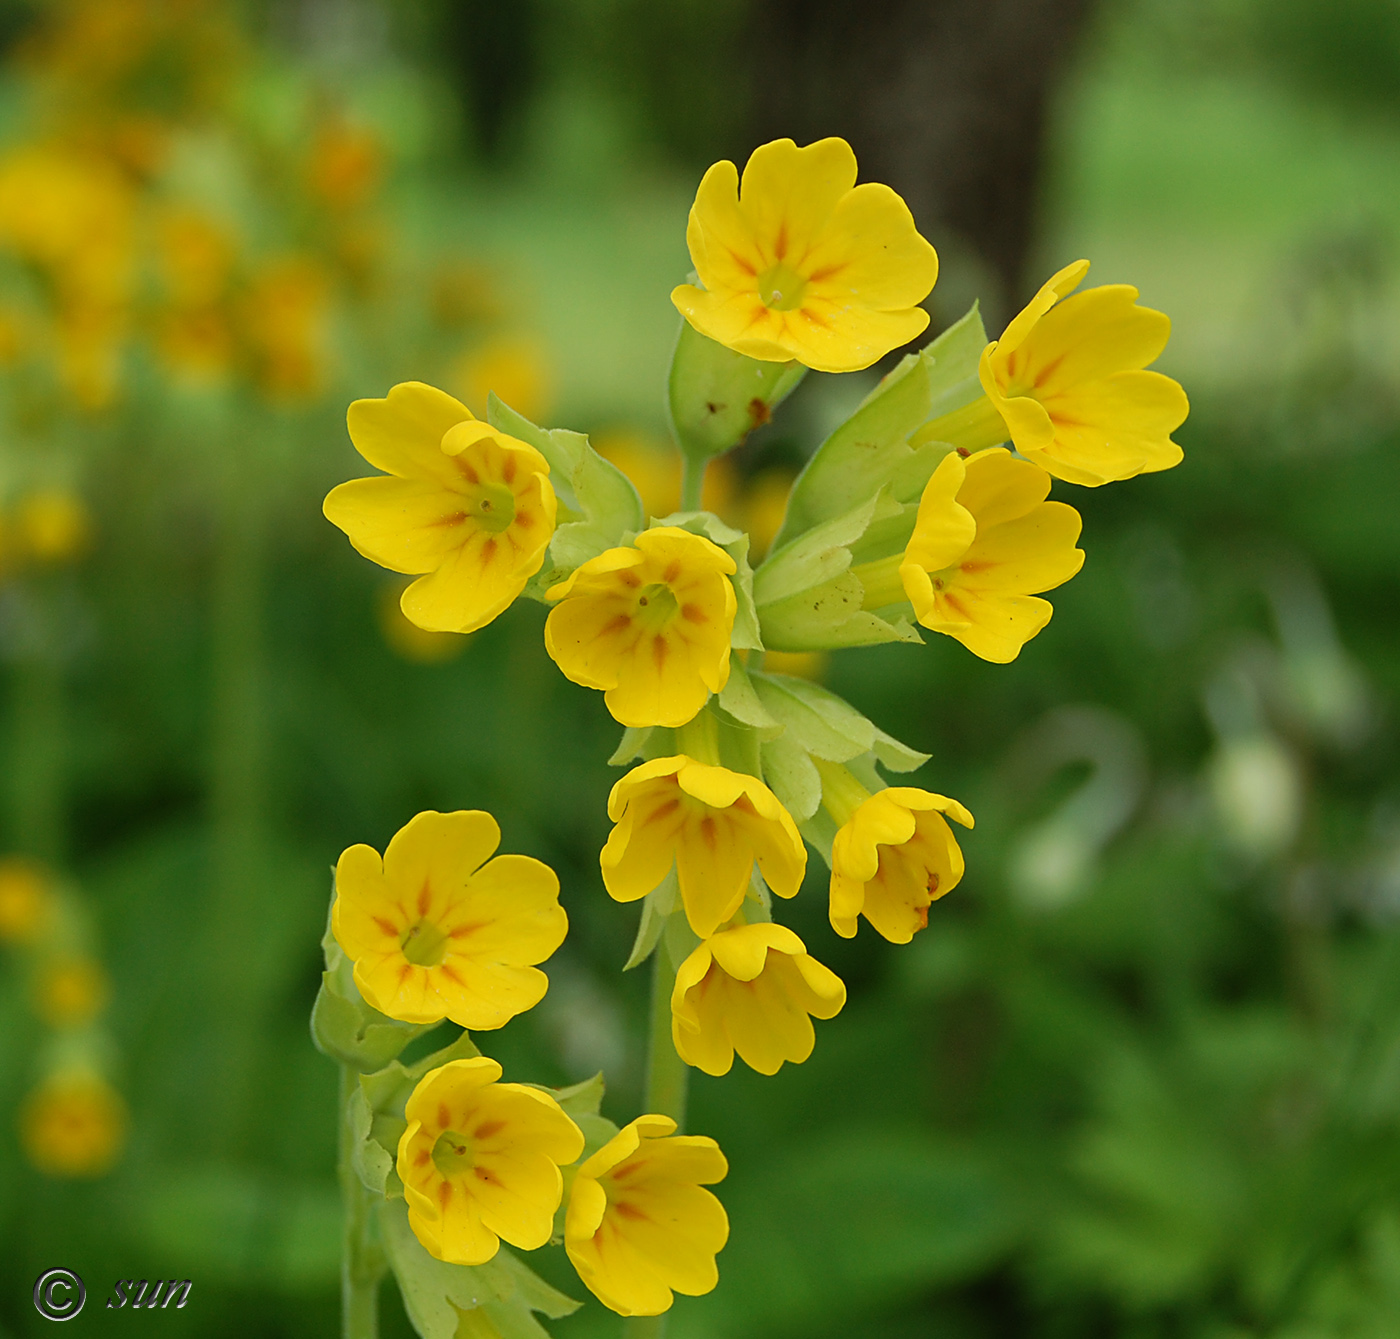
[[823, 772, 973, 944]]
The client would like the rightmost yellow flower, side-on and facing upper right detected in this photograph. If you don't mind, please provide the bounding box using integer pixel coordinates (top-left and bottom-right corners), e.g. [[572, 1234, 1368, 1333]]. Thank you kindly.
[[979, 261, 1190, 487]]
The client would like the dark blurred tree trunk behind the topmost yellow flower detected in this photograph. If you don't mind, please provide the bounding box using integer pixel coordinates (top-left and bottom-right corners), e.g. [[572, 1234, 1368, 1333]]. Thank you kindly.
[[750, 0, 1091, 332]]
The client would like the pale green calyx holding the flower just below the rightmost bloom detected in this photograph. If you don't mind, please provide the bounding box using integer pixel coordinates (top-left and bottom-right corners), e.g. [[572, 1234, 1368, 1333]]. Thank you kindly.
[[753, 489, 924, 651]]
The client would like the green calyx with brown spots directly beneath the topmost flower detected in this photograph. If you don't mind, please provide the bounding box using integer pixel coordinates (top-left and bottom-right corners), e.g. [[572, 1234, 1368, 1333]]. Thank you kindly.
[[668, 321, 806, 459]]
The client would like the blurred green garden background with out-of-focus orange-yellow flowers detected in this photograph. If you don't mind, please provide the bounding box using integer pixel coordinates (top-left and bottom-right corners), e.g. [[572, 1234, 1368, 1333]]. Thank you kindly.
[[0, 0, 1400, 1339]]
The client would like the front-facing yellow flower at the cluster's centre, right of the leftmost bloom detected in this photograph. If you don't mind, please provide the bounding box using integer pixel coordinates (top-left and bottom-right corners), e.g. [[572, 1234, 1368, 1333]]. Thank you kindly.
[[545, 525, 738, 727]]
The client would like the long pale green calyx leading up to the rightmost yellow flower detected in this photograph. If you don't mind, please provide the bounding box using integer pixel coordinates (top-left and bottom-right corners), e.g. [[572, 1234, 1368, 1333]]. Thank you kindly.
[[773, 303, 987, 548]]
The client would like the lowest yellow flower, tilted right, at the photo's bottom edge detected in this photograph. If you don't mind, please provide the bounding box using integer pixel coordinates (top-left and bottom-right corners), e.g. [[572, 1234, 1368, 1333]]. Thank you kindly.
[[564, 1116, 729, 1315]]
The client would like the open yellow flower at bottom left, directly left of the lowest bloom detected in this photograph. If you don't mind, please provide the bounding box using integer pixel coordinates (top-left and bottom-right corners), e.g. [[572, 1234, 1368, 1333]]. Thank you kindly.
[[399, 1056, 584, 1265]]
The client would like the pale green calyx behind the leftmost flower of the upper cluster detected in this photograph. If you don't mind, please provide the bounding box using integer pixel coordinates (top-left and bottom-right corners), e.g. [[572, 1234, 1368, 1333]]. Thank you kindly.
[[486, 392, 647, 579]]
